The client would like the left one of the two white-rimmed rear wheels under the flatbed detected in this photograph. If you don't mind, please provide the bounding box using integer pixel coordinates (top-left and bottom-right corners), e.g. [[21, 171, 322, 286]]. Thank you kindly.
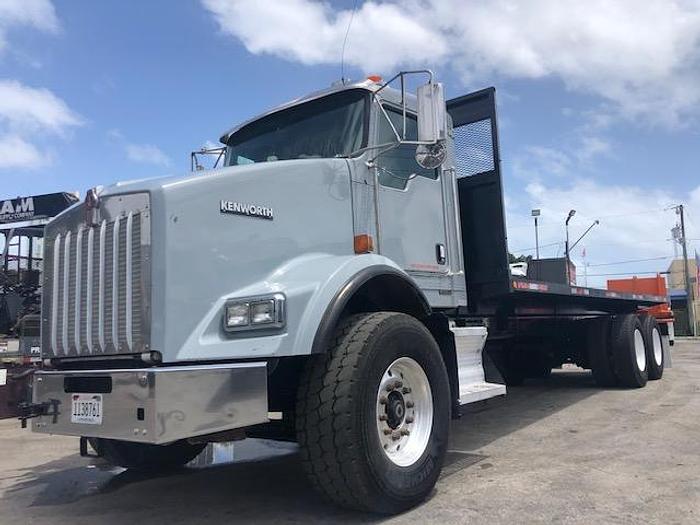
[[610, 314, 648, 388]]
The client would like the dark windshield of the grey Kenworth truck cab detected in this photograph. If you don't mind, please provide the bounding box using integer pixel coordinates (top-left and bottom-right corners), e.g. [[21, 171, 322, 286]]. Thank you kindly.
[[226, 89, 369, 166]]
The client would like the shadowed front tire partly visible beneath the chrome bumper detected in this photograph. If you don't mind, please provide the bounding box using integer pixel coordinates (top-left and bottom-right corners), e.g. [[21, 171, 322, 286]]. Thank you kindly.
[[89, 438, 206, 471]]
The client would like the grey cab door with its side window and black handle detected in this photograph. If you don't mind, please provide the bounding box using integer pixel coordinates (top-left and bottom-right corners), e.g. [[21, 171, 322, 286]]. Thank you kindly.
[[375, 105, 449, 277]]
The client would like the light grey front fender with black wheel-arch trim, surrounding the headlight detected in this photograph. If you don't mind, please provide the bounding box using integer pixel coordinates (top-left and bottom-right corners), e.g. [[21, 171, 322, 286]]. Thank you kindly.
[[169, 253, 430, 361]]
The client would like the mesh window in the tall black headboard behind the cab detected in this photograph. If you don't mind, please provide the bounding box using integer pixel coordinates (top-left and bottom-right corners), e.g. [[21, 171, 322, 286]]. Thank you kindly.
[[454, 119, 495, 178]]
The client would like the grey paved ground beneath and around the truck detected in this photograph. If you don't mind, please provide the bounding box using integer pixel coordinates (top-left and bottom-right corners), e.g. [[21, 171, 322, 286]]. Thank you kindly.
[[0, 341, 700, 525]]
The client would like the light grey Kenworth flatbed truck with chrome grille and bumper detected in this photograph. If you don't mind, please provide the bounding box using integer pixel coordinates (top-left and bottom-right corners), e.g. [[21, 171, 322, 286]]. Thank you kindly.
[[25, 71, 668, 513]]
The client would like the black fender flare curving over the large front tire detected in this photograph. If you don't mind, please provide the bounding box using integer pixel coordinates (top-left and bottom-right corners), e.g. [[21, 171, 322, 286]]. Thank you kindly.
[[311, 264, 431, 354]]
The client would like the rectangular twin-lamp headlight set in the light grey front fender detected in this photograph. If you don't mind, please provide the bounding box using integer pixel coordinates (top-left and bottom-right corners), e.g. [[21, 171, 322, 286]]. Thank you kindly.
[[223, 293, 286, 332]]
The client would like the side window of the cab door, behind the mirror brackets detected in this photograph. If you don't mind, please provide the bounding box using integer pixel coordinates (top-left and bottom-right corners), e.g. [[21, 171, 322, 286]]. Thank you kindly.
[[376, 106, 437, 190]]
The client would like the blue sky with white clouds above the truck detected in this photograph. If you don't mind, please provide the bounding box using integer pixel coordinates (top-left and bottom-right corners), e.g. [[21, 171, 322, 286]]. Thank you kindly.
[[0, 0, 700, 286]]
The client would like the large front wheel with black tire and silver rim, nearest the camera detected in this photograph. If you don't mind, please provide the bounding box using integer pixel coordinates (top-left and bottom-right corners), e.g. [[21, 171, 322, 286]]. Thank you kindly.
[[296, 312, 450, 514]]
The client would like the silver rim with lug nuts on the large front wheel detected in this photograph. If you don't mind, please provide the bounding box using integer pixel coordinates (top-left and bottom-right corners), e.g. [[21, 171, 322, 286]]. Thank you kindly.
[[375, 357, 433, 467]]
